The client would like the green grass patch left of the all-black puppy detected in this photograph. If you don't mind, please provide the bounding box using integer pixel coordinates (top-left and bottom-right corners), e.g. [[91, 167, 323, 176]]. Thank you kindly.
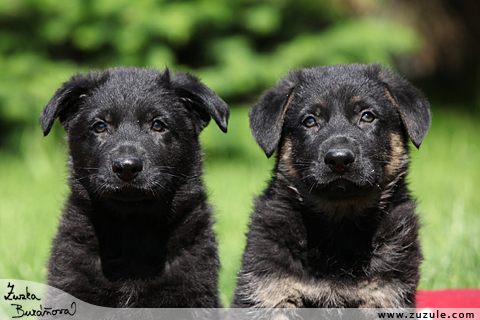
[[0, 129, 66, 282]]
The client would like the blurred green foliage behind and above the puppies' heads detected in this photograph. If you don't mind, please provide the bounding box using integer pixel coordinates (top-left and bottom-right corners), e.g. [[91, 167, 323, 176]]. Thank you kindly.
[[0, 0, 421, 146]]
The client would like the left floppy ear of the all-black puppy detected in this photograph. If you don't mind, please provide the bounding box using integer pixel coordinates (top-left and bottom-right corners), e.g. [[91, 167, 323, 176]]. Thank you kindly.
[[40, 71, 110, 136]]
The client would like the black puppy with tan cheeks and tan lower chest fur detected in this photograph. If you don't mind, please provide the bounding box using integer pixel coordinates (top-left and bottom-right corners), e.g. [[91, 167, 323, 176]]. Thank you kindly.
[[233, 64, 431, 308]]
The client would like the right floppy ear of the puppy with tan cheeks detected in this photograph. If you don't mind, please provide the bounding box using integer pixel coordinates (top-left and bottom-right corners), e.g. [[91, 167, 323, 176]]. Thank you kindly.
[[380, 68, 432, 148]]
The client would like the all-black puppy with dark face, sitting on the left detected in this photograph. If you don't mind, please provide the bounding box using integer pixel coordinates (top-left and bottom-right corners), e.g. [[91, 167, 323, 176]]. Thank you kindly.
[[40, 68, 229, 308]]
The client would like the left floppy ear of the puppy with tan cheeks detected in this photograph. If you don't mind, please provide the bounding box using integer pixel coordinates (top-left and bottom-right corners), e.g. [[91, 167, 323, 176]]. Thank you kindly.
[[249, 71, 300, 158]]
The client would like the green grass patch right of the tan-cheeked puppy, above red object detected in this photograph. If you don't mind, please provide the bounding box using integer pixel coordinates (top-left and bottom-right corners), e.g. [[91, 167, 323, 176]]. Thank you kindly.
[[410, 107, 480, 288]]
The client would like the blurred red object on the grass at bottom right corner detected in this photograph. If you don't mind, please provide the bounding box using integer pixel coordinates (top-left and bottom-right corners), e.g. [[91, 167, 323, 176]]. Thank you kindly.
[[416, 289, 480, 308]]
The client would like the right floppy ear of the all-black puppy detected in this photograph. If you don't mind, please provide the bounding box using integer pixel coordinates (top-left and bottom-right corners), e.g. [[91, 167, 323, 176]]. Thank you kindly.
[[166, 68, 230, 132]]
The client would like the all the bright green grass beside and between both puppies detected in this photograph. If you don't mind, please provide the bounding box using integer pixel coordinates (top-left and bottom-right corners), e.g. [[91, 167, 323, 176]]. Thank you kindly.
[[0, 108, 480, 305]]
